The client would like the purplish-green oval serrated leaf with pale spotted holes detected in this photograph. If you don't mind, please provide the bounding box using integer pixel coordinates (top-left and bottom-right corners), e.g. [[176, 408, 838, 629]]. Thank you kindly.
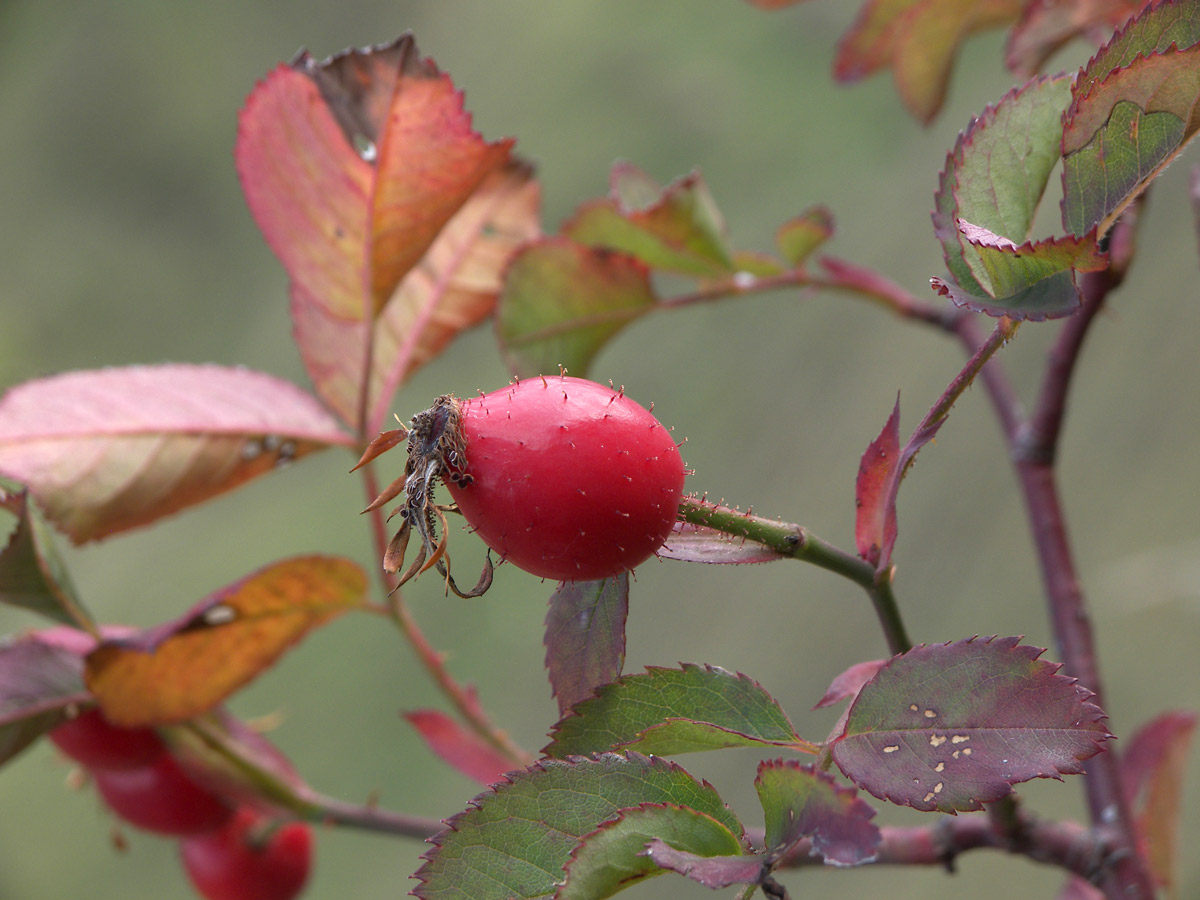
[[830, 637, 1111, 812]]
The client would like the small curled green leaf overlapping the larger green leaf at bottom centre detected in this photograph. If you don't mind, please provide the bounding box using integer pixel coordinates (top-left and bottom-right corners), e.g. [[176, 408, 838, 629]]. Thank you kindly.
[[554, 803, 742, 900]]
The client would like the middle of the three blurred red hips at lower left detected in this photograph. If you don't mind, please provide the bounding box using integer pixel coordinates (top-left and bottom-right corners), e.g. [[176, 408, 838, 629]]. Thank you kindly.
[[94, 754, 233, 834]]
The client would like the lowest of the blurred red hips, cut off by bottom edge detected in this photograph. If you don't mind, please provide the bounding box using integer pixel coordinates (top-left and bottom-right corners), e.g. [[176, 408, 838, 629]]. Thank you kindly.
[[179, 809, 312, 900]]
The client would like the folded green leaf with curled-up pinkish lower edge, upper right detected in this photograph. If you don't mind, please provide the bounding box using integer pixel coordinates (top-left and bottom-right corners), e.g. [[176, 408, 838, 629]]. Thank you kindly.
[[931, 76, 1106, 320]]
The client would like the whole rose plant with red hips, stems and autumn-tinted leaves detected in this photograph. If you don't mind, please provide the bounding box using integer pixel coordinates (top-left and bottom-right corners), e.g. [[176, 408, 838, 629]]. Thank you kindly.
[[0, 0, 1200, 900]]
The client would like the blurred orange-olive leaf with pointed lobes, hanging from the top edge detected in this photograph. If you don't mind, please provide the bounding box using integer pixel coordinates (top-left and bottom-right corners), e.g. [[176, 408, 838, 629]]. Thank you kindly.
[[834, 0, 1021, 124]]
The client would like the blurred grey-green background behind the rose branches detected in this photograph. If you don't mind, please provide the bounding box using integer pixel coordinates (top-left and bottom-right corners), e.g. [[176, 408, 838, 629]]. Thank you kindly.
[[0, 0, 1200, 900]]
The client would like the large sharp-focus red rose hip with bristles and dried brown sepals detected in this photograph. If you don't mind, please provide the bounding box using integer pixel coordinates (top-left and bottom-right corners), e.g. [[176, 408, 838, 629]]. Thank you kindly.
[[384, 376, 684, 585]]
